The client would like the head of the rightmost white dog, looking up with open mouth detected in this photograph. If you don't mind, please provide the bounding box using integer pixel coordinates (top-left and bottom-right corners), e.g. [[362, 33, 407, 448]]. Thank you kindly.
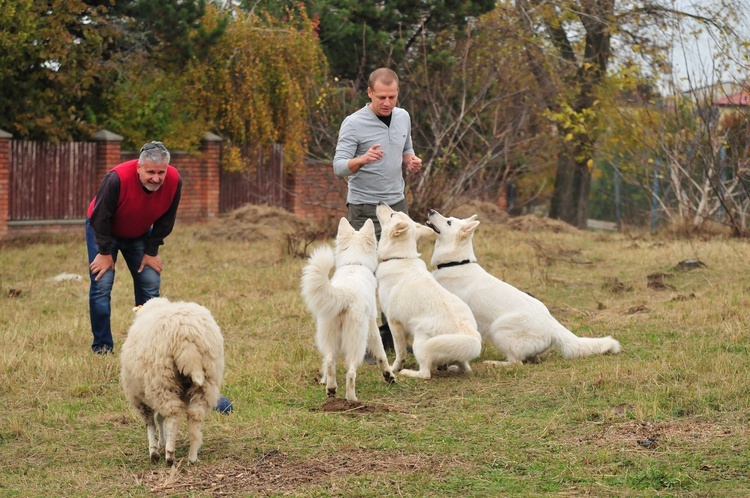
[[425, 209, 479, 266]]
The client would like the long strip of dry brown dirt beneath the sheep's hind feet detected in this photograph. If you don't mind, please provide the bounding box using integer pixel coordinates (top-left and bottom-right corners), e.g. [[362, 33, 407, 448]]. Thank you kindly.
[[139, 449, 450, 497]]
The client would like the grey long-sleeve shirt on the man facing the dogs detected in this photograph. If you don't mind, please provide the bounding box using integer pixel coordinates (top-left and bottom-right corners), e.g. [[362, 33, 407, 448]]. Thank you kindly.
[[333, 105, 414, 204]]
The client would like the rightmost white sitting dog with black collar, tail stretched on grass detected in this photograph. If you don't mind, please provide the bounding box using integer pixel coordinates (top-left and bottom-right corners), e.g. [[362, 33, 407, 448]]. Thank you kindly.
[[427, 209, 620, 365]]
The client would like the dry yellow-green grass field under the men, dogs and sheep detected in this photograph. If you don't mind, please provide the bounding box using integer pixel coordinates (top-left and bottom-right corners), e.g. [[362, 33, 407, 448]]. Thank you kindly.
[[0, 208, 750, 497]]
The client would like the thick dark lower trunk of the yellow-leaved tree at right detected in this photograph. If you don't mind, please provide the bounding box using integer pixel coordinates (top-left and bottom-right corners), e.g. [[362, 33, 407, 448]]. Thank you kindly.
[[550, 143, 591, 229]]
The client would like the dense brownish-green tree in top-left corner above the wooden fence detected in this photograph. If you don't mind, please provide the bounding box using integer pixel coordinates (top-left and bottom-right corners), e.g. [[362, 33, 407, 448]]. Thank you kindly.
[[0, 0, 117, 141]]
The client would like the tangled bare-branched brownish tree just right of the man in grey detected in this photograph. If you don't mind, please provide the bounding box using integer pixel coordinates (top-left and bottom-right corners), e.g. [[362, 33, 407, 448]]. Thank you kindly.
[[402, 11, 550, 216]]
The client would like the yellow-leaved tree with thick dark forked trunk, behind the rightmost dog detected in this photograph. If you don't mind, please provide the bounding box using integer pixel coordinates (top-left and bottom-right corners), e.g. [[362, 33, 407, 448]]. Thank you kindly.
[[508, 0, 739, 227]]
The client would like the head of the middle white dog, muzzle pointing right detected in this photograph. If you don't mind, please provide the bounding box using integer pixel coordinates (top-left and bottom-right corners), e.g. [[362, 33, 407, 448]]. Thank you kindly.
[[375, 204, 433, 259]]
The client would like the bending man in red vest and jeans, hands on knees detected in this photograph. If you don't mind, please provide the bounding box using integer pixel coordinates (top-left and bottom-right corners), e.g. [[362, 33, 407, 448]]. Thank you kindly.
[[86, 142, 182, 354]]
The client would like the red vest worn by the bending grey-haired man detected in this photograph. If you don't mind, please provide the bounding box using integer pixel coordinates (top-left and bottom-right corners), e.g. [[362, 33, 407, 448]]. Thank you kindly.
[[88, 159, 180, 239]]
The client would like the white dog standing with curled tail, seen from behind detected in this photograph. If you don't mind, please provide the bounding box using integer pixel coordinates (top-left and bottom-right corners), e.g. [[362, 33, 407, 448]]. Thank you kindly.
[[302, 218, 395, 401]]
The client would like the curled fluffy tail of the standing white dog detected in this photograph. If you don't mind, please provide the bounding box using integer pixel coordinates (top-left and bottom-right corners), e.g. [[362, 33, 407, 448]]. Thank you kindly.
[[302, 246, 342, 316]]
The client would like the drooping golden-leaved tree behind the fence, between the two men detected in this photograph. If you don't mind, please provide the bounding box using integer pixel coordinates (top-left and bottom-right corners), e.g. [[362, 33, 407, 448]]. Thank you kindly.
[[187, 3, 326, 167]]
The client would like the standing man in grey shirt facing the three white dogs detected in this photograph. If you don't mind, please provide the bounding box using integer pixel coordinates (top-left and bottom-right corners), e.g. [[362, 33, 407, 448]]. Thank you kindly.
[[333, 67, 422, 347]]
